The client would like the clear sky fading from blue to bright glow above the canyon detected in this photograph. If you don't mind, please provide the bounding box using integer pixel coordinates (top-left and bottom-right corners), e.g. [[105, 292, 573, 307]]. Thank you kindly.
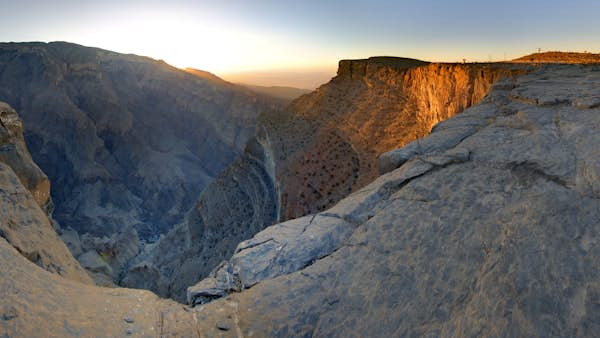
[[0, 0, 600, 88]]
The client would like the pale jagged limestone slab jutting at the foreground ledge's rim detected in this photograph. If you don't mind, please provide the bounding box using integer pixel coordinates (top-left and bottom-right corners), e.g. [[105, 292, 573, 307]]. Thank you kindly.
[[187, 214, 355, 305]]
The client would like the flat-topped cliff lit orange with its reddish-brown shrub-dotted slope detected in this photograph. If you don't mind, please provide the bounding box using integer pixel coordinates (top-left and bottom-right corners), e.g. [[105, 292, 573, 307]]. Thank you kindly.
[[278, 57, 525, 220]]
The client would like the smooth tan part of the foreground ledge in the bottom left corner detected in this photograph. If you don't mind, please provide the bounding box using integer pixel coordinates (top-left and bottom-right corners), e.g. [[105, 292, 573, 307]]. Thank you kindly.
[[0, 236, 197, 337]]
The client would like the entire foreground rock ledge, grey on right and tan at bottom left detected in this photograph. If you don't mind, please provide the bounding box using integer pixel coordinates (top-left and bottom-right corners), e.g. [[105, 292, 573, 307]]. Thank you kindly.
[[0, 65, 600, 337]]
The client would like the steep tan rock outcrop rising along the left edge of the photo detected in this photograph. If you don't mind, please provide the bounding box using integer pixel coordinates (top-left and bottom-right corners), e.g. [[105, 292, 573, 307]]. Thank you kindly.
[[0, 102, 93, 284]]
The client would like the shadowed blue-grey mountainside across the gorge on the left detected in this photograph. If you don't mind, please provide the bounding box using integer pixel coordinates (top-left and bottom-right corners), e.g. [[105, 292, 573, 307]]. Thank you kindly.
[[0, 42, 273, 239]]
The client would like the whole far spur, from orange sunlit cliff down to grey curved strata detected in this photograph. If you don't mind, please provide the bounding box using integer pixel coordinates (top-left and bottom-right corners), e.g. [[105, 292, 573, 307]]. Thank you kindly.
[[137, 57, 528, 300]]
